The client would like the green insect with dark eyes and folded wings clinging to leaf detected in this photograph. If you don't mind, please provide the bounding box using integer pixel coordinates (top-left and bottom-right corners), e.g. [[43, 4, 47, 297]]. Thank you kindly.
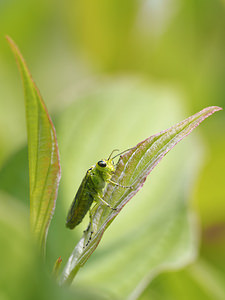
[[66, 149, 132, 229]]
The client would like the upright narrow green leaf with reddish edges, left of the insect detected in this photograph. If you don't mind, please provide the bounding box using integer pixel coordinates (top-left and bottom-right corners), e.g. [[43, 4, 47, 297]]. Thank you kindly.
[[7, 37, 60, 254]]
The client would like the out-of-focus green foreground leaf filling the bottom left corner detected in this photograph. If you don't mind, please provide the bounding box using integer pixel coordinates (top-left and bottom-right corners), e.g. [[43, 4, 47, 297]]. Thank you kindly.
[[0, 191, 104, 300]]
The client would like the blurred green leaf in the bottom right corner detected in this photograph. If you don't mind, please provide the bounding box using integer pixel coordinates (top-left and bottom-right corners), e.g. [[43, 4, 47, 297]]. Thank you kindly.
[[141, 257, 225, 300]]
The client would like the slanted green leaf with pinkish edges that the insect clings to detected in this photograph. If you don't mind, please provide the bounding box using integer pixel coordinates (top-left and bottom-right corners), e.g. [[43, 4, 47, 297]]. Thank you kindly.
[[61, 107, 221, 284]]
